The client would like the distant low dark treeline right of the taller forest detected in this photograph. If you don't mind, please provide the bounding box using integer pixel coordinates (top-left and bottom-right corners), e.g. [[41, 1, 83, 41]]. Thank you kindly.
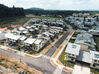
[[25, 9, 98, 17]]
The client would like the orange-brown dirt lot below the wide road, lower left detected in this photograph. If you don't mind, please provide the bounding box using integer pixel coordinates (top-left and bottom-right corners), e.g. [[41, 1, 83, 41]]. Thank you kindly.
[[0, 53, 42, 74]]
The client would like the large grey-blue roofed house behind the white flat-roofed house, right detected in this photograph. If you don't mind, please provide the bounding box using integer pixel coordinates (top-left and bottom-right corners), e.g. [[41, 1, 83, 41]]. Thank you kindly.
[[75, 33, 96, 50]]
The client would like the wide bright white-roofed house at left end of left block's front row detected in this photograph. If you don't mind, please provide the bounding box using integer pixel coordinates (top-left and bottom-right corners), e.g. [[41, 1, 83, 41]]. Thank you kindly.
[[5, 33, 21, 46]]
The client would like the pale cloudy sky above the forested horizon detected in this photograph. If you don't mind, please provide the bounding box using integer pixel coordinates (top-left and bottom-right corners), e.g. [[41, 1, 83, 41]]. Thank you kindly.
[[0, 0, 99, 10]]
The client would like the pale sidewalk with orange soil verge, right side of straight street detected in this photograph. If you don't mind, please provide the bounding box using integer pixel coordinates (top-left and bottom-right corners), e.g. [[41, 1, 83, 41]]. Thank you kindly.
[[51, 31, 74, 72]]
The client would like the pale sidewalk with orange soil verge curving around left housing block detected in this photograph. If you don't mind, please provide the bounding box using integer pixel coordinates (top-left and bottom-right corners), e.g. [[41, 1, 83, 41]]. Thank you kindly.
[[0, 32, 65, 58]]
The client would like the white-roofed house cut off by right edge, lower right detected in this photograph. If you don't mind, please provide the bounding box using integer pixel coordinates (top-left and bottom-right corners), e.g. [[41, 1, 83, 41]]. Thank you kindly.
[[90, 51, 99, 69]]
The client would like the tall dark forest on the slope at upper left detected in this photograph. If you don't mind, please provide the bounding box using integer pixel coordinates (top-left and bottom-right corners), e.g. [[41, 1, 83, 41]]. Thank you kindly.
[[0, 4, 25, 19]]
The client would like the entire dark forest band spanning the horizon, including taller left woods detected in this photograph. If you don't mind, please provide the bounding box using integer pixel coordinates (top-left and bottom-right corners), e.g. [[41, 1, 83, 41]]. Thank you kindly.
[[0, 4, 98, 25]]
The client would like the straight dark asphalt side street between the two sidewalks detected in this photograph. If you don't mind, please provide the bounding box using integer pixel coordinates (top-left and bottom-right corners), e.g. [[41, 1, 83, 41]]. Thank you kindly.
[[45, 31, 70, 57]]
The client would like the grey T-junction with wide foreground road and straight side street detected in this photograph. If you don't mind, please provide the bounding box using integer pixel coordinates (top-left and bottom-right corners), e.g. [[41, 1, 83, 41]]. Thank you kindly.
[[0, 31, 72, 74]]
